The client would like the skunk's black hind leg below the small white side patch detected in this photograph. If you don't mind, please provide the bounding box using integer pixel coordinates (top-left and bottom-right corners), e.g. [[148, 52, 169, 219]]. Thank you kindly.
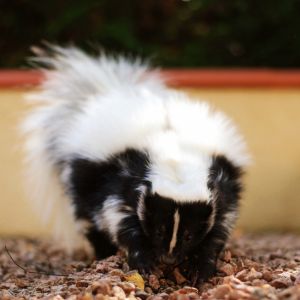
[[86, 227, 117, 260]]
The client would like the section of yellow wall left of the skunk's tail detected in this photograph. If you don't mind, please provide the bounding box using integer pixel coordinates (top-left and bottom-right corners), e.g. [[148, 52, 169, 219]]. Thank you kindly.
[[0, 90, 45, 234]]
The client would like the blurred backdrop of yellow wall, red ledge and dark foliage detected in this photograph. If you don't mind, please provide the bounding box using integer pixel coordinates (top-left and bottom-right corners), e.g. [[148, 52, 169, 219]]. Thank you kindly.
[[0, 0, 300, 235]]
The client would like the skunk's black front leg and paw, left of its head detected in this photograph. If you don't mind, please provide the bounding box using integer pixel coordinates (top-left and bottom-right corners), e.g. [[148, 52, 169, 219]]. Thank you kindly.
[[118, 215, 155, 274]]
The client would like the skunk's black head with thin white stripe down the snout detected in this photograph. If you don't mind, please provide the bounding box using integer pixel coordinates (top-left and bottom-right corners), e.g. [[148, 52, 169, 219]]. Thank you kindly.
[[144, 194, 214, 263]]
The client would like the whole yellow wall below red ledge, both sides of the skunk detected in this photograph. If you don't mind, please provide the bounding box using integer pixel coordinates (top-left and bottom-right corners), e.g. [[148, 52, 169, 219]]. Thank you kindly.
[[0, 89, 300, 234]]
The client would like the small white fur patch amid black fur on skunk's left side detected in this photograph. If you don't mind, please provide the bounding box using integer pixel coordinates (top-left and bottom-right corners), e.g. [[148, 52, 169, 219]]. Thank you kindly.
[[94, 196, 130, 243]]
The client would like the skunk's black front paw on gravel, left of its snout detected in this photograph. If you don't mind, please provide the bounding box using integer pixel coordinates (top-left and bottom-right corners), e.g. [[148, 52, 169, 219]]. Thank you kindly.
[[128, 250, 155, 275]]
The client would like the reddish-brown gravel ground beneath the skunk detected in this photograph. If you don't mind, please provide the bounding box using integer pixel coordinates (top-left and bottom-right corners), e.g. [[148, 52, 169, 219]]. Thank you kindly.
[[0, 234, 300, 300]]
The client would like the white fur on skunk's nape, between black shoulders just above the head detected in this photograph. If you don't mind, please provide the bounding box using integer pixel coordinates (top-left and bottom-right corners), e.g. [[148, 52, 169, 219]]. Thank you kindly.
[[148, 132, 212, 203]]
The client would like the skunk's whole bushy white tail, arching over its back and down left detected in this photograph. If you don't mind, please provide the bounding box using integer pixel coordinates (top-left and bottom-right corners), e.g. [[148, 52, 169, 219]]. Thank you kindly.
[[22, 46, 163, 250]]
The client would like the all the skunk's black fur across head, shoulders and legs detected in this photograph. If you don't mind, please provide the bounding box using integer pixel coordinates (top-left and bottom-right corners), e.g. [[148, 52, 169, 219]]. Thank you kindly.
[[69, 149, 241, 284]]
